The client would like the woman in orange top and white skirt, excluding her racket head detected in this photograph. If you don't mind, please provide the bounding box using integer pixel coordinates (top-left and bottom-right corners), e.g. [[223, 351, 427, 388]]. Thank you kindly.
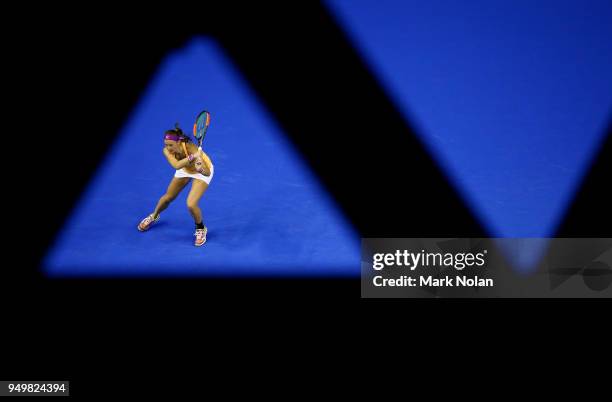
[[138, 124, 215, 246]]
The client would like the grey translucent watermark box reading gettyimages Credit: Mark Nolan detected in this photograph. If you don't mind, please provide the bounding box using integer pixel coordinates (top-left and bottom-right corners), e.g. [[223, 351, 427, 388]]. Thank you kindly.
[[361, 238, 612, 298]]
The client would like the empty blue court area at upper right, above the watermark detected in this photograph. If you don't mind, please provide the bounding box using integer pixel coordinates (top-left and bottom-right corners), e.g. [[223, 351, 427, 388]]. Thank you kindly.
[[326, 0, 612, 237]]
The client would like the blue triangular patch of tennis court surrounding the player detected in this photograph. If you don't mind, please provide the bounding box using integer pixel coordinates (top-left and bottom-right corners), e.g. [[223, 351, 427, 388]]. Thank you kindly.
[[44, 38, 360, 277]]
